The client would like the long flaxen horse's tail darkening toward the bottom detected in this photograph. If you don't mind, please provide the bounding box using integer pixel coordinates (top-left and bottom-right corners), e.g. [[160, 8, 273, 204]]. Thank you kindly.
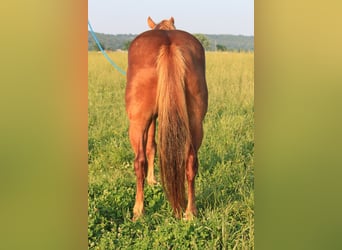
[[157, 44, 191, 217]]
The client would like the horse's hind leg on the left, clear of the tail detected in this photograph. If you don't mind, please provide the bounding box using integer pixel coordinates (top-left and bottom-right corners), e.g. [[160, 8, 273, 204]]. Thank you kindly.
[[129, 122, 147, 220]]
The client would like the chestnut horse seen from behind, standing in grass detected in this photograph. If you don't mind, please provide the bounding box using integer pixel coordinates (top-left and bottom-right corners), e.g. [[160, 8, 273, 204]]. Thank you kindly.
[[125, 17, 208, 220]]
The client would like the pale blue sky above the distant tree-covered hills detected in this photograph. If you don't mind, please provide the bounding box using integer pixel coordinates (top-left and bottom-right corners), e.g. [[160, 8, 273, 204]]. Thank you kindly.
[[88, 0, 254, 36]]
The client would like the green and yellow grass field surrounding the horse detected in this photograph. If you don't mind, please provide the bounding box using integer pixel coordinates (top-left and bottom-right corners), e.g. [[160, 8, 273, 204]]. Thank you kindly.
[[88, 52, 254, 249]]
